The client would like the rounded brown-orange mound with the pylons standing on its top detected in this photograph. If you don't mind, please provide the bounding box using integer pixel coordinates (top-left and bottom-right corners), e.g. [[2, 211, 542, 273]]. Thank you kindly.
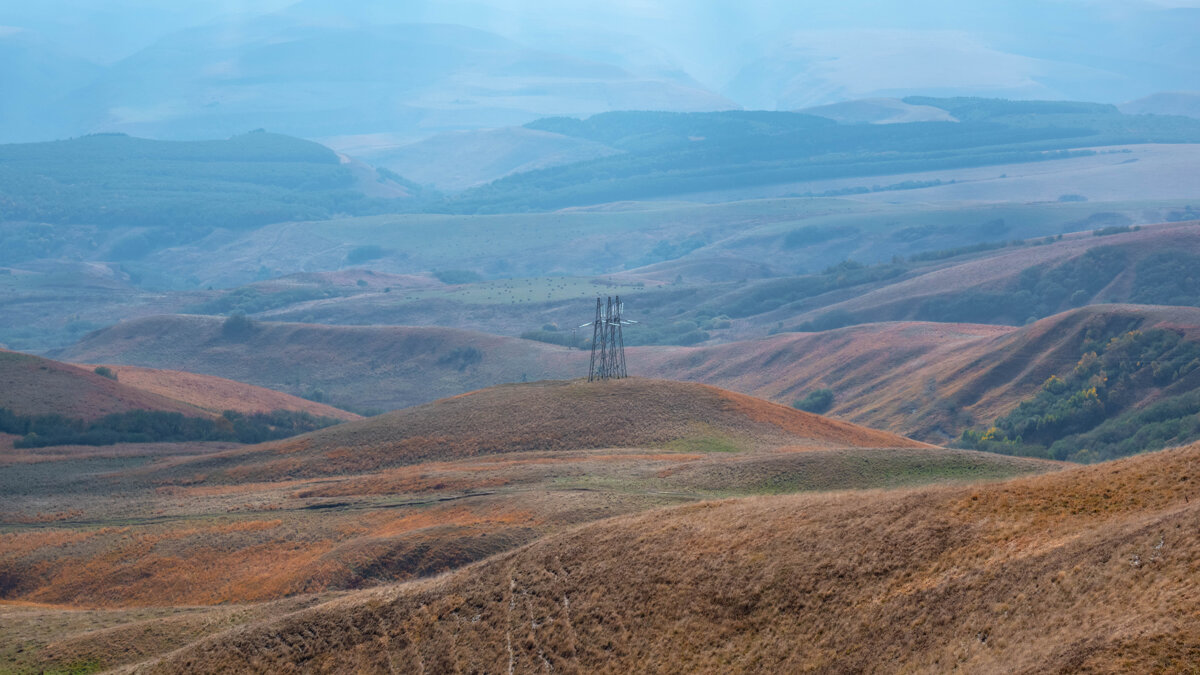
[[181, 378, 925, 480]]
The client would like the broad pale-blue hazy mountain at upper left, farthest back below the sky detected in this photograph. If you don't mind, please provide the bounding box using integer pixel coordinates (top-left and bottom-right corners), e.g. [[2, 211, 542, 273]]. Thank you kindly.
[[12, 11, 737, 141]]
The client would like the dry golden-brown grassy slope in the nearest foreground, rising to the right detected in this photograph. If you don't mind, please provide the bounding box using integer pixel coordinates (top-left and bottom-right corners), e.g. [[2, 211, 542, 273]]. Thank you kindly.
[[145, 446, 1200, 674]]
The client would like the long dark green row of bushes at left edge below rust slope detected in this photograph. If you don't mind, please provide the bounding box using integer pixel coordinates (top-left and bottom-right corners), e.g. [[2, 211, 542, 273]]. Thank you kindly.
[[0, 408, 341, 448]]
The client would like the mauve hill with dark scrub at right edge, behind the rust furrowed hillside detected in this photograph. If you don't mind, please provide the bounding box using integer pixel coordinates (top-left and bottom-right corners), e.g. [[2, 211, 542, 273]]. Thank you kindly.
[[758, 219, 1200, 329]]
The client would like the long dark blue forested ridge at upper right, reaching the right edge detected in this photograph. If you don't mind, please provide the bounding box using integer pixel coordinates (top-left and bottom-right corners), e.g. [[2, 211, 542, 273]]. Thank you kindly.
[[446, 103, 1200, 213]]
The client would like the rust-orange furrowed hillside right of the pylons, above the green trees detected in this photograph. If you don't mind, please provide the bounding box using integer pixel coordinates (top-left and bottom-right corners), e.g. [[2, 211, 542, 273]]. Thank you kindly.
[[630, 305, 1200, 443]]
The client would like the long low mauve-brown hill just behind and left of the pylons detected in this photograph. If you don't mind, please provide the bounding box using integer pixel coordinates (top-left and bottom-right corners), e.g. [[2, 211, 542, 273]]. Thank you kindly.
[[56, 316, 587, 411]]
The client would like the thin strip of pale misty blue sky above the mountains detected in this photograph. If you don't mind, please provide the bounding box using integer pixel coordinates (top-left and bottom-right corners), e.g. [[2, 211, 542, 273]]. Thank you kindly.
[[11, 0, 1200, 89]]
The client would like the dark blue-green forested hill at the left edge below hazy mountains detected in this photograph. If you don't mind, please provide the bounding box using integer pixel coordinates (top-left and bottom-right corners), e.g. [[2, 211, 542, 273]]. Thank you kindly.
[[0, 130, 413, 234]]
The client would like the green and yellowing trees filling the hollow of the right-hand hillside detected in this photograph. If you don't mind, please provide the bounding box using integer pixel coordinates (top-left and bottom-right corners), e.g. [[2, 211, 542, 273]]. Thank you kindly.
[[959, 329, 1200, 461]]
